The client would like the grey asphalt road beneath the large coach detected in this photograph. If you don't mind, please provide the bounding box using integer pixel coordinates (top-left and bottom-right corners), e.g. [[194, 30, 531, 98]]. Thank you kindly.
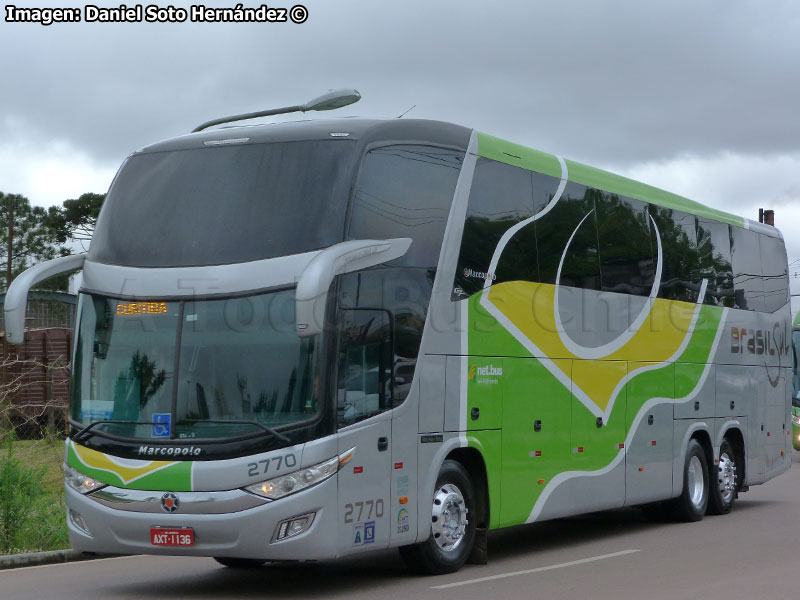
[[0, 453, 800, 600]]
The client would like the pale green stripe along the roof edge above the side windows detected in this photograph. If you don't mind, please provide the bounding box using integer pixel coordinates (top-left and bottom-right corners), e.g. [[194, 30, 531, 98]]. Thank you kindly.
[[478, 132, 745, 227]]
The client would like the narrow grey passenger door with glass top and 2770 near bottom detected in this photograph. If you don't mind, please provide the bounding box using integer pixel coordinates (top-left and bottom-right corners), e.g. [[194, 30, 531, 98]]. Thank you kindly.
[[336, 309, 394, 554]]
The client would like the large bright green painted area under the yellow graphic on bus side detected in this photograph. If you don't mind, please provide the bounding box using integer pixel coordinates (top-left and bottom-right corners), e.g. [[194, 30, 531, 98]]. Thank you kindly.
[[466, 292, 724, 528]]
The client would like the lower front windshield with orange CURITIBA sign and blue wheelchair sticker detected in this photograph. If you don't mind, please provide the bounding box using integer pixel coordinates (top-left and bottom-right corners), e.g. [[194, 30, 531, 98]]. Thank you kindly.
[[71, 290, 320, 441]]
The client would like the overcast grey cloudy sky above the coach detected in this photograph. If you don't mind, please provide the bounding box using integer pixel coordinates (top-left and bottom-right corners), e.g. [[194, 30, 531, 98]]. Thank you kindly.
[[0, 0, 800, 308]]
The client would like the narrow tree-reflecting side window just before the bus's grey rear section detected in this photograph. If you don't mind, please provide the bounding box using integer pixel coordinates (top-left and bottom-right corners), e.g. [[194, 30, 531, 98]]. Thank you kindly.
[[697, 217, 733, 307]]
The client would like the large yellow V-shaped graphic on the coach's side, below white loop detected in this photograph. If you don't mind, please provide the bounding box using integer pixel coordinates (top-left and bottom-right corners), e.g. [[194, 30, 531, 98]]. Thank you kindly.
[[484, 281, 696, 411]]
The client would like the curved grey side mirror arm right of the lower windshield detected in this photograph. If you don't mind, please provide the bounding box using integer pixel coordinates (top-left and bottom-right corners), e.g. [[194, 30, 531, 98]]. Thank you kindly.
[[295, 238, 411, 337]]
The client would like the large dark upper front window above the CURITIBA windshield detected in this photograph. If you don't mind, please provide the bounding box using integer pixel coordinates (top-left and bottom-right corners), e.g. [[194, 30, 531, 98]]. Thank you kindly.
[[89, 140, 354, 267]]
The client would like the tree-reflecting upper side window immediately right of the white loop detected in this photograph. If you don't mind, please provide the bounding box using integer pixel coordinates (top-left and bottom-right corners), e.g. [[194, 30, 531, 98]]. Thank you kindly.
[[650, 206, 700, 302]]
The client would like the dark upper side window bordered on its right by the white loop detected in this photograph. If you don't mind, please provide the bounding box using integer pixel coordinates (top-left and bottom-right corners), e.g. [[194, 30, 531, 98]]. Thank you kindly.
[[595, 192, 655, 296]]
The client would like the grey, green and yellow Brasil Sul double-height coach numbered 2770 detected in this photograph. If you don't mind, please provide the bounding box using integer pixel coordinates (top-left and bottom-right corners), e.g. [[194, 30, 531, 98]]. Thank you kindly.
[[5, 118, 791, 573]]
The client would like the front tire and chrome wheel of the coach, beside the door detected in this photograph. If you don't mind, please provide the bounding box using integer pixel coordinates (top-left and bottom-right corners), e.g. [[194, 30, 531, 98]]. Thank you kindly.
[[400, 460, 478, 575]]
